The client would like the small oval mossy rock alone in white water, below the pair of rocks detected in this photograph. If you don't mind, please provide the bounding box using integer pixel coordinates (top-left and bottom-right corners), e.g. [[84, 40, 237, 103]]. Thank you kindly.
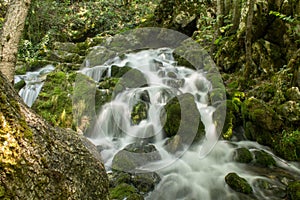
[[225, 173, 253, 194]]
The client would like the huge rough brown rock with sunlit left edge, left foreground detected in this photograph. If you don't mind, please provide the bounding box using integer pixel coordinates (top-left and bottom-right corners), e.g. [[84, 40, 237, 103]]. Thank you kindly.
[[0, 75, 108, 200]]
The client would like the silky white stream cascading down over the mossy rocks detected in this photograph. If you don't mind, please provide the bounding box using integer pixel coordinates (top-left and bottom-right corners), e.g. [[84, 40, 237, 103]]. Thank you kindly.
[[16, 48, 300, 200]]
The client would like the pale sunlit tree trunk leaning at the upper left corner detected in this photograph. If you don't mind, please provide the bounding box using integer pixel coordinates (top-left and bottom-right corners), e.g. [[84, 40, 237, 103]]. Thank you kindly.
[[0, 0, 30, 83]]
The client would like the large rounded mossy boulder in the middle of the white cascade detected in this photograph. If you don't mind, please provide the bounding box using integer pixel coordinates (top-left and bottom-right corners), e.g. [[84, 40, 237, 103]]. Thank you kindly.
[[161, 94, 205, 143]]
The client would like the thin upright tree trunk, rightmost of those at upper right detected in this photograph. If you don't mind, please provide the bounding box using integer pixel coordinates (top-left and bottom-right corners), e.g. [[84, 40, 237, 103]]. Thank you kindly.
[[244, 0, 255, 78]]
